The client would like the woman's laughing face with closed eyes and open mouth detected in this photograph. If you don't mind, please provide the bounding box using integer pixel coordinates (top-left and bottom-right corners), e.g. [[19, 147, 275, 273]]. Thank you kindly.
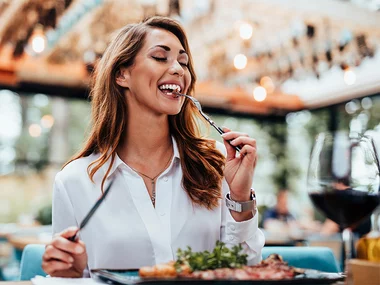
[[117, 28, 191, 115]]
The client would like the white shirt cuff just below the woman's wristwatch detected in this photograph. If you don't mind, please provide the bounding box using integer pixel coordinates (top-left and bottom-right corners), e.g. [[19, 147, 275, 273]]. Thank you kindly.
[[226, 205, 258, 243]]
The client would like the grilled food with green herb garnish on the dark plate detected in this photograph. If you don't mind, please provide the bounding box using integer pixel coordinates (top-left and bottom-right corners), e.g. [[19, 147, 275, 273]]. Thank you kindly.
[[139, 242, 303, 280]]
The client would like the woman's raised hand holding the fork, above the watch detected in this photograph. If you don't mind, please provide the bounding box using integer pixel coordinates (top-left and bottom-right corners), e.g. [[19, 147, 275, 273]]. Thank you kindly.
[[222, 128, 257, 202]]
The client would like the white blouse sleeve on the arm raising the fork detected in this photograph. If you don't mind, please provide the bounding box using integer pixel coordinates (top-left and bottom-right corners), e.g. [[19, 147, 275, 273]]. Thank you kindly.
[[220, 180, 265, 265]]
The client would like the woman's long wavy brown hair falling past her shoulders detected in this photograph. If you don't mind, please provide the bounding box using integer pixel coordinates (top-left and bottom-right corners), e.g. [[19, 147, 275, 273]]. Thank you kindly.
[[65, 17, 225, 209]]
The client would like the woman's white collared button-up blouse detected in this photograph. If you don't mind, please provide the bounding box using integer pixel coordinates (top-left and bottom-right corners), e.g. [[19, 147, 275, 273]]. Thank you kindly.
[[53, 139, 264, 276]]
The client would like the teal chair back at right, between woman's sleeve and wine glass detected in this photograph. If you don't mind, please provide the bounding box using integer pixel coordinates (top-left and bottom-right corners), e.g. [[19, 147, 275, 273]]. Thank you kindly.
[[262, 246, 340, 272]]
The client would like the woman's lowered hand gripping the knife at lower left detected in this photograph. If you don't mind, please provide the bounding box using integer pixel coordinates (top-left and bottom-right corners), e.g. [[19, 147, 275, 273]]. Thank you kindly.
[[42, 227, 87, 278]]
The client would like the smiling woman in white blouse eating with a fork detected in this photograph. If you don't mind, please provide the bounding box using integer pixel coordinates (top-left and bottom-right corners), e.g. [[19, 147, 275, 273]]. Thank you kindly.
[[43, 17, 264, 277]]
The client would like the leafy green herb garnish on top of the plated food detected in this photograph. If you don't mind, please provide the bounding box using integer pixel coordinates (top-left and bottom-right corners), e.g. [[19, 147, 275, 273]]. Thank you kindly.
[[175, 241, 247, 271]]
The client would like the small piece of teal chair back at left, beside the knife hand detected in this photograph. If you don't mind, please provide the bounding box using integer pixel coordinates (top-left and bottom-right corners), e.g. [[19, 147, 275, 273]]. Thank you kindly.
[[20, 244, 47, 281]]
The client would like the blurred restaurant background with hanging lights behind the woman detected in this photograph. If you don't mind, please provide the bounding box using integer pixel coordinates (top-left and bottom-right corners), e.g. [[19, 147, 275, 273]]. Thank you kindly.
[[0, 0, 380, 280]]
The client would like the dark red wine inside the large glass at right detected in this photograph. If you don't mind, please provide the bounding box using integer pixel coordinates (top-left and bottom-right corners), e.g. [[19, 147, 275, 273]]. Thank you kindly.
[[310, 189, 380, 228]]
